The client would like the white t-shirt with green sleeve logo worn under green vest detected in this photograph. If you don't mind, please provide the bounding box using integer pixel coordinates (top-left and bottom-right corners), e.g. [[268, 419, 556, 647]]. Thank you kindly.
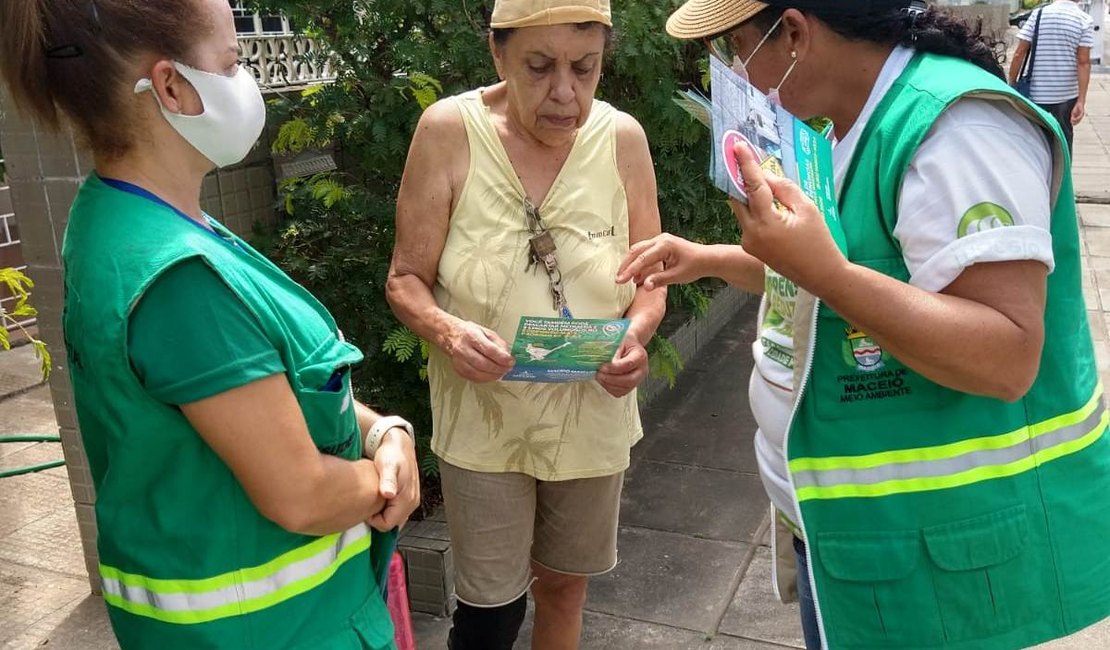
[[748, 47, 1055, 522]]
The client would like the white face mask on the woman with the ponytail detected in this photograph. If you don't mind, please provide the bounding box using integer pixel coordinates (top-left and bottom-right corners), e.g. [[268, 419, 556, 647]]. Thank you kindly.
[[135, 61, 266, 167]]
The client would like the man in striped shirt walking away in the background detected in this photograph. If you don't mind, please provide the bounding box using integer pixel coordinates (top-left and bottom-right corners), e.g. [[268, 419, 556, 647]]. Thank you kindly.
[[1010, 0, 1094, 150]]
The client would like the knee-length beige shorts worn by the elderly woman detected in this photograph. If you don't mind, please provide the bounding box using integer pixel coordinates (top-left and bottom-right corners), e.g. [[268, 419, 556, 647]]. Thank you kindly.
[[440, 460, 624, 607]]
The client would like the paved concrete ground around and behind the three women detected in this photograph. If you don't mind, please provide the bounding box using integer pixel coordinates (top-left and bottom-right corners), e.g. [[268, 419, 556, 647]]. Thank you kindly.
[[0, 37, 1110, 650]]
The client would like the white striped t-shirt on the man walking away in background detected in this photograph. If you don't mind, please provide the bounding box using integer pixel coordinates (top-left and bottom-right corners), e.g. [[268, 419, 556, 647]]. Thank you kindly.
[[1018, 0, 1094, 104]]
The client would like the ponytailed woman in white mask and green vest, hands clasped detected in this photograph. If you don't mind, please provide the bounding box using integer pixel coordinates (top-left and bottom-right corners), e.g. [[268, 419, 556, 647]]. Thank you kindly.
[[0, 0, 420, 650]]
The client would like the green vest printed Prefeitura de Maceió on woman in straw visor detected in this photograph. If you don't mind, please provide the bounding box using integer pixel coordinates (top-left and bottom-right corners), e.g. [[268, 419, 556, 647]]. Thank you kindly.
[[787, 54, 1110, 650]]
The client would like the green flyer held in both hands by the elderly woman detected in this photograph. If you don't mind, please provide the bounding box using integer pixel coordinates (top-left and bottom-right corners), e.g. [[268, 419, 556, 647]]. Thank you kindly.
[[502, 316, 628, 384]]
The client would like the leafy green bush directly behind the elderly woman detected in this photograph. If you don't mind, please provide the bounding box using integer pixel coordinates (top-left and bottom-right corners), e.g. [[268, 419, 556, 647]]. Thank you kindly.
[[247, 0, 738, 488]]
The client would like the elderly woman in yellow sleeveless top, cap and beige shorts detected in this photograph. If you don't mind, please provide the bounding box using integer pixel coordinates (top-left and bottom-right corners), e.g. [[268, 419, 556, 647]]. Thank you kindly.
[[387, 0, 665, 650]]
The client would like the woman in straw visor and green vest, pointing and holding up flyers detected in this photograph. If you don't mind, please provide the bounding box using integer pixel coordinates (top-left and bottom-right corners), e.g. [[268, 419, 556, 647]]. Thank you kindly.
[[619, 0, 1110, 649]]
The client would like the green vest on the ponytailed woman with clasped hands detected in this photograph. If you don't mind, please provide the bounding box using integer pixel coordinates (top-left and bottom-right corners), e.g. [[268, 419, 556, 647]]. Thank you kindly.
[[62, 174, 393, 650]]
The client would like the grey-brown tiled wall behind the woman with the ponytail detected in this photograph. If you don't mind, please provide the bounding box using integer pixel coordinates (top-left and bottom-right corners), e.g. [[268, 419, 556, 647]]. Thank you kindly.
[[0, 84, 278, 591]]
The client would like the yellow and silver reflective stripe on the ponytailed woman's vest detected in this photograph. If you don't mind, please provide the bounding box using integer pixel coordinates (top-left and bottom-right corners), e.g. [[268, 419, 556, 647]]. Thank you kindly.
[[100, 524, 371, 624]]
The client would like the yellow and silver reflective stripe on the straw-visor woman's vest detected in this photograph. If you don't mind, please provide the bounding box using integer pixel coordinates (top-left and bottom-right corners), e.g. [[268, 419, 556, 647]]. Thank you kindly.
[[789, 384, 1110, 501]]
